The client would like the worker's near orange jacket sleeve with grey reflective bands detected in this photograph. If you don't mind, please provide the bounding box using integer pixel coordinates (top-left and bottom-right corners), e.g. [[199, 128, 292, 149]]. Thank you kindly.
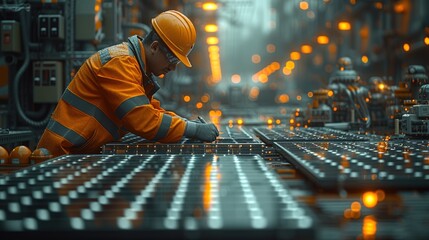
[[96, 57, 187, 142]]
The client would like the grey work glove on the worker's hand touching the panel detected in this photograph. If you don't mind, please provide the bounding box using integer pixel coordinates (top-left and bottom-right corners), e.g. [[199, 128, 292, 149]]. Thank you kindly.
[[185, 121, 219, 142]]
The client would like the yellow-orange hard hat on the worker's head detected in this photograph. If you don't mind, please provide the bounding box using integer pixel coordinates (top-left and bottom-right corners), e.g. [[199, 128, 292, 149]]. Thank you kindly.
[[152, 10, 197, 67]]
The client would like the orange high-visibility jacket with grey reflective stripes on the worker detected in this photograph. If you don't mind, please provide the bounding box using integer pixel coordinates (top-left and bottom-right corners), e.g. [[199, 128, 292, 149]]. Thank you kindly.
[[37, 36, 187, 156]]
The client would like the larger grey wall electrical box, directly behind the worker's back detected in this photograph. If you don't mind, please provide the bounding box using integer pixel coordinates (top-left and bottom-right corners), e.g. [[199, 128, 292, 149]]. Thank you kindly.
[[33, 61, 64, 103]]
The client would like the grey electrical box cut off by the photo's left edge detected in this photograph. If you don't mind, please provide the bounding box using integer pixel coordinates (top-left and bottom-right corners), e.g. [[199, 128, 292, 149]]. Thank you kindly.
[[1, 20, 21, 53]]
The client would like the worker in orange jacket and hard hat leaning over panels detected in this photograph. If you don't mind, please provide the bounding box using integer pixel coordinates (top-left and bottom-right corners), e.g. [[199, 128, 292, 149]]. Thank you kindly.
[[37, 10, 219, 156]]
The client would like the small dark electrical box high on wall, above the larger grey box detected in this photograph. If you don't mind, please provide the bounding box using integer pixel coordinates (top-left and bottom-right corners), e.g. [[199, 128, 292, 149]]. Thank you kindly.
[[38, 14, 64, 39]]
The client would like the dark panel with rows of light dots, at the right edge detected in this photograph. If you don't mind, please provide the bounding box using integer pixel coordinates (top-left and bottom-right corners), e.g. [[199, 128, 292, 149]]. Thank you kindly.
[[274, 141, 429, 190]]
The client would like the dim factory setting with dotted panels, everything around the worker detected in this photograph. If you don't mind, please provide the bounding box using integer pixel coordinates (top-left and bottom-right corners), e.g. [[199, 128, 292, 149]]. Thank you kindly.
[[0, 0, 429, 239]]
